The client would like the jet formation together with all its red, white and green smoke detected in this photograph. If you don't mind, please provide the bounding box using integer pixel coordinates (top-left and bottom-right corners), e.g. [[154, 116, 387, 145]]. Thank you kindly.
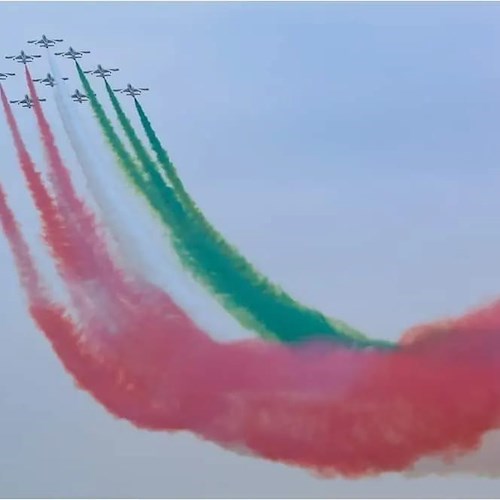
[[0, 35, 500, 477]]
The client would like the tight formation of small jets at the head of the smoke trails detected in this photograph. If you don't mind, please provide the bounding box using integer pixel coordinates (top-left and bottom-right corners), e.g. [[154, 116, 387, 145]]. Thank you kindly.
[[0, 35, 149, 109]]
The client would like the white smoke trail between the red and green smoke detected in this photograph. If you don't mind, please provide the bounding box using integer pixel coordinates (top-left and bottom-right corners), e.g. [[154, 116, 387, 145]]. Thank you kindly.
[[48, 53, 252, 340]]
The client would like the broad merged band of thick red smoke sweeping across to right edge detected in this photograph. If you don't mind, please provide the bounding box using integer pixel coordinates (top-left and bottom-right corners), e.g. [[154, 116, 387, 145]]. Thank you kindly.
[[4, 96, 500, 476]]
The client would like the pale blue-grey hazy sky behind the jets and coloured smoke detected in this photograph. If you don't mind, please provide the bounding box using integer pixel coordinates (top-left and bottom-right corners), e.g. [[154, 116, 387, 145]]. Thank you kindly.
[[0, 2, 500, 498]]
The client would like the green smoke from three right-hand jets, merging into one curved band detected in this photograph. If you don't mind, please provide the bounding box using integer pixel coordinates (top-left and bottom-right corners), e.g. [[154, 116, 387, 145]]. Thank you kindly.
[[79, 63, 390, 347]]
